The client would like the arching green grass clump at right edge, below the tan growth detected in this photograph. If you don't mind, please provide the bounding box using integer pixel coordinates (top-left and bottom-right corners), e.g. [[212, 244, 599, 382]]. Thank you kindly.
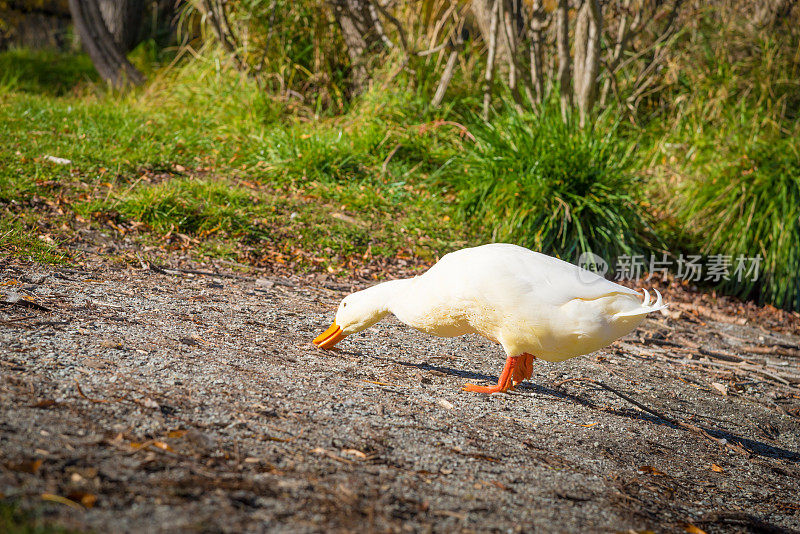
[[678, 138, 800, 310]]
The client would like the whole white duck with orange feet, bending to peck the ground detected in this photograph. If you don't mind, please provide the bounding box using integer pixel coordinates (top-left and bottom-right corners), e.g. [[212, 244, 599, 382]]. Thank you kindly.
[[314, 244, 666, 393]]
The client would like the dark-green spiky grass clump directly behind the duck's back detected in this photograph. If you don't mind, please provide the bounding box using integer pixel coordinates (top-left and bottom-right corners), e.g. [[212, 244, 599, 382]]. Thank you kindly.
[[447, 109, 659, 262]]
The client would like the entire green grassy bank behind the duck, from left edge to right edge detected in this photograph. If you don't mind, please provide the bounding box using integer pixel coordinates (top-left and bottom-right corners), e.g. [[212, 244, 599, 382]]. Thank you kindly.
[[0, 32, 800, 308]]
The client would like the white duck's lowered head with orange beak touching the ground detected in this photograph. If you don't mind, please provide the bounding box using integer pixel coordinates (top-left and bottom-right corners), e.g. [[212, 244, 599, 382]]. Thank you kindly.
[[313, 284, 390, 349]]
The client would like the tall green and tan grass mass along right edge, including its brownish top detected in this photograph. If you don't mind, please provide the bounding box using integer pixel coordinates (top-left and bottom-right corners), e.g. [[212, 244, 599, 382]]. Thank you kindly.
[[644, 19, 800, 310]]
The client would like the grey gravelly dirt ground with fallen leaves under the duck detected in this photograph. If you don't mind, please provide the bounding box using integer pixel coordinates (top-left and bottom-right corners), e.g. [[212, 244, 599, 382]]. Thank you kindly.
[[0, 260, 800, 533]]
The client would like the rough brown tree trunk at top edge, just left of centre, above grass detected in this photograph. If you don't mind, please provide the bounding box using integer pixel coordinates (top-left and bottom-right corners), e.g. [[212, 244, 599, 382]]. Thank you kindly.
[[329, 0, 381, 93]]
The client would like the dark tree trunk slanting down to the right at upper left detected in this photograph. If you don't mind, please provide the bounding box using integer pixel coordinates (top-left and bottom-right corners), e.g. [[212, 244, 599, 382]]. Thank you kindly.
[[69, 0, 144, 88]]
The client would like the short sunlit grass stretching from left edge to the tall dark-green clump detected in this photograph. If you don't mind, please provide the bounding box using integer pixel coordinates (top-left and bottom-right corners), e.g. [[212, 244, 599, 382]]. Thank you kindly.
[[0, 50, 454, 268]]
